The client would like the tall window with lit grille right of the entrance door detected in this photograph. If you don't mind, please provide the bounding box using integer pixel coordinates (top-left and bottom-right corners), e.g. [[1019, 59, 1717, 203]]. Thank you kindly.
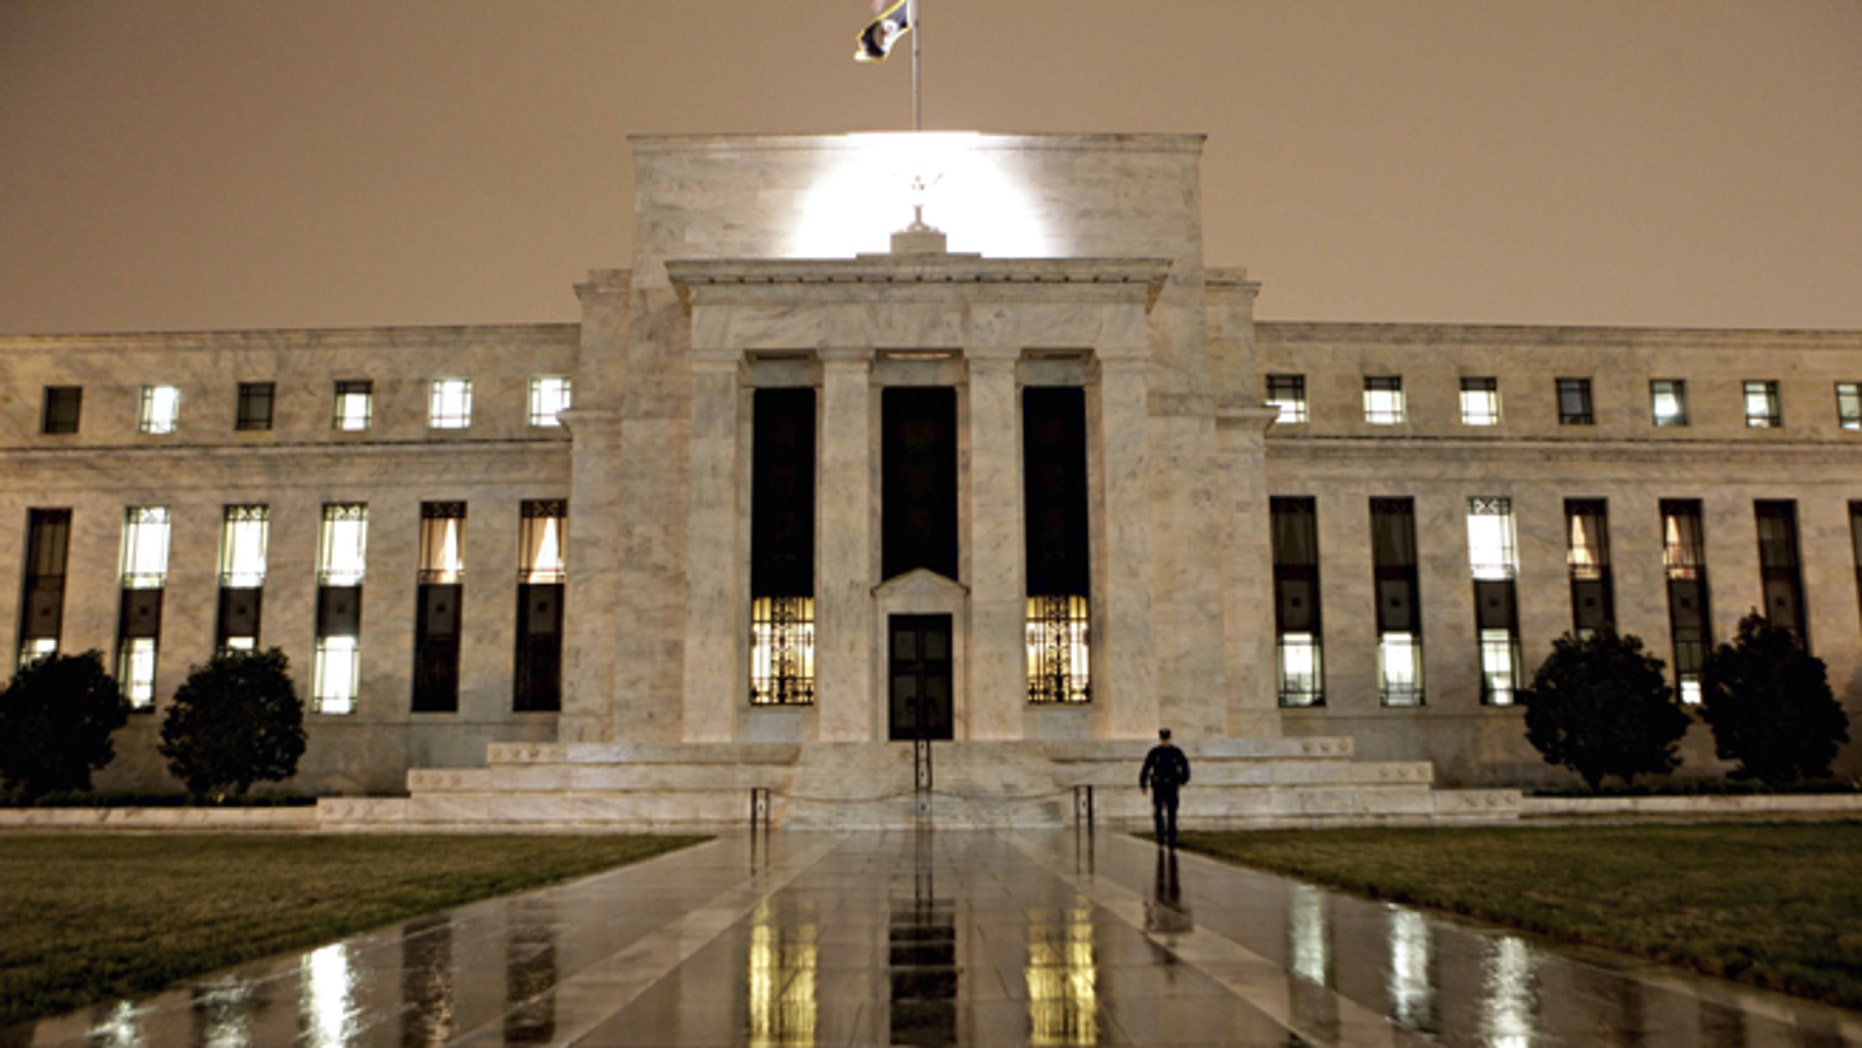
[[1022, 385, 1093, 704]]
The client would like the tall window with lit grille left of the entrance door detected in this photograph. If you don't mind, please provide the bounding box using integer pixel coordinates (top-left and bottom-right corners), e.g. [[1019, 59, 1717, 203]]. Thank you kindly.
[[750, 387, 816, 705]]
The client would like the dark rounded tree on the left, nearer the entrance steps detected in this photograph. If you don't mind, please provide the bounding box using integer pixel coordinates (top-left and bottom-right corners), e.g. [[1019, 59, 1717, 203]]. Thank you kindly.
[[160, 648, 305, 800]]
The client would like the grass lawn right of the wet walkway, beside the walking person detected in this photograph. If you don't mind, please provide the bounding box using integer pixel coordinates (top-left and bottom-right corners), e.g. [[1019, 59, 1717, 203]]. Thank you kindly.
[[1181, 823, 1862, 1007]]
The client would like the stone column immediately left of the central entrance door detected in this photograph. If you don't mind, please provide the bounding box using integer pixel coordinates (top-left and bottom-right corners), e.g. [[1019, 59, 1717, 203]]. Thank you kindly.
[[816, 348, 875, 743]]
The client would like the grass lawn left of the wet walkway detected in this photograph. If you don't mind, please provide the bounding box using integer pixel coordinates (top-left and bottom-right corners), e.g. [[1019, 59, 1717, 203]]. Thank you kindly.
[[0, 834, 704, 1026]]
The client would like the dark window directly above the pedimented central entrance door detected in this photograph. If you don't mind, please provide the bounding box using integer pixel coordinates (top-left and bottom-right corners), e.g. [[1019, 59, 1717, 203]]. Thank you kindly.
[[879, 385, 957, 579]]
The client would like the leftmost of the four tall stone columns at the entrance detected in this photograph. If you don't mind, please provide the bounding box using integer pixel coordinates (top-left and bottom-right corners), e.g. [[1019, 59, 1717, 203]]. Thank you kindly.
[[683, 350, 749, 743]]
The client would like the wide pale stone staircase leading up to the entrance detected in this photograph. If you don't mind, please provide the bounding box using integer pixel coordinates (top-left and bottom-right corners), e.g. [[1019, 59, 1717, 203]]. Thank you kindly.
[[317, 737, 1521, 832]]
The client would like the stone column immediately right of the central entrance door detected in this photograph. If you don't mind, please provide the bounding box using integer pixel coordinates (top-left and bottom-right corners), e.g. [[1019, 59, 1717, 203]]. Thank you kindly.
[[966, 348, 1028, 739]]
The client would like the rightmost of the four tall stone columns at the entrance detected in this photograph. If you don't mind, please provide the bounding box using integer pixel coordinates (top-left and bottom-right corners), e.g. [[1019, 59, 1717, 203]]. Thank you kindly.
[[1087, 350, 1158, 739]]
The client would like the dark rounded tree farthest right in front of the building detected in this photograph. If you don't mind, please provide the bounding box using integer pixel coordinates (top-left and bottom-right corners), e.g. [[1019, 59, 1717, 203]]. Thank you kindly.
[[1700, 612, 1849, 786]]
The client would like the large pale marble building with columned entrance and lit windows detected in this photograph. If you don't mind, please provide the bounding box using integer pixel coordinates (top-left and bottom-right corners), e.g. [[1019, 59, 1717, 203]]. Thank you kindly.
[[0, 136, 1862, 804]]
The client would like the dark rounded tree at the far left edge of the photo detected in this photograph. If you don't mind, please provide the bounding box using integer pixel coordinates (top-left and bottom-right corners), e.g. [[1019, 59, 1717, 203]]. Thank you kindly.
[[0, 652, 128, 799]]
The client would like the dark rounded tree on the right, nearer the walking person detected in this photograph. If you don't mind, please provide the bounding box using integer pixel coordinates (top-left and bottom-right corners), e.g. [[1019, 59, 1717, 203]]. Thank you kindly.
[[1521, 627, 1693, 789]]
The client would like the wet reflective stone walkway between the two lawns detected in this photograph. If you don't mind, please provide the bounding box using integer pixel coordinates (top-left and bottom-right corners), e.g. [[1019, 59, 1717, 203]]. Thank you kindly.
[[14, 830, 1862, 1048]]
